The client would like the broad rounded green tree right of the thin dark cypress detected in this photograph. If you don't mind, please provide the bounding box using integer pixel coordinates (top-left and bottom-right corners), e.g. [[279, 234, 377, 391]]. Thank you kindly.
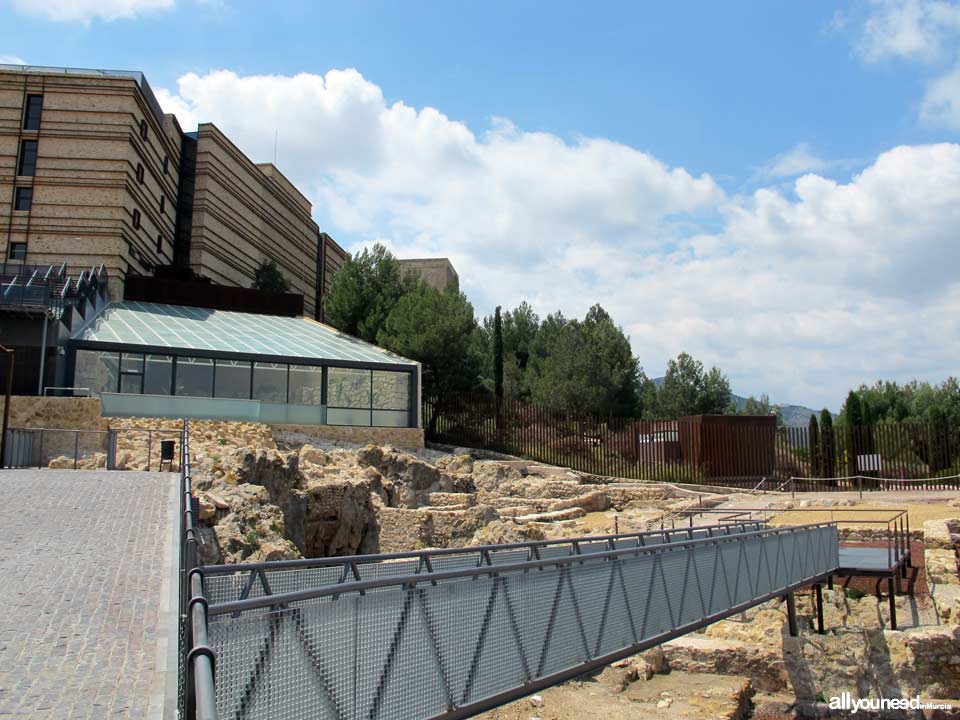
[[528, 305, 640, 415]]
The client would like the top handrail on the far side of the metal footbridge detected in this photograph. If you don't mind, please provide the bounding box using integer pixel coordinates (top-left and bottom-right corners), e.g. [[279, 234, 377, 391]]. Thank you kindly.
[[202, 520, 765, 576]]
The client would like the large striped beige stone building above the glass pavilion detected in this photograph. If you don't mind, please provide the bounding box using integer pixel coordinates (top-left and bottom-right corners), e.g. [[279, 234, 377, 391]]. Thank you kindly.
[[0, 65, 347, 319]]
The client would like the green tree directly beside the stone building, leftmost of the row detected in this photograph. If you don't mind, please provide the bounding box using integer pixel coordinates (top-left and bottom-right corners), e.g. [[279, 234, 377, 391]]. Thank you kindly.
[[323, 243, 420, 343]]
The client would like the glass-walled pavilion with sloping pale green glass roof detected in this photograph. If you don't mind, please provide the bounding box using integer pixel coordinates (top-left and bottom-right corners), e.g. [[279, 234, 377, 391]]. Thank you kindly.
[[68, 301, 420, 427]]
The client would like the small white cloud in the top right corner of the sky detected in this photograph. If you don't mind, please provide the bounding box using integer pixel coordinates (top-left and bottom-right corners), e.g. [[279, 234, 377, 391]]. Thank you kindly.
[[856, 0, 960, 62]]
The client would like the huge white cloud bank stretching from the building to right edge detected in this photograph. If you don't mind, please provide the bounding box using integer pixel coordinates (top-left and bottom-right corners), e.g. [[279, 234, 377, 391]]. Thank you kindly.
[[158, 70, 960, 409]]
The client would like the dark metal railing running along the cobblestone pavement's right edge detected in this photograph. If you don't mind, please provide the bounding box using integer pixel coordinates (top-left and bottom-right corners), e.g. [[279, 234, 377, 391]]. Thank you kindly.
[[180, 420, 217, 720]]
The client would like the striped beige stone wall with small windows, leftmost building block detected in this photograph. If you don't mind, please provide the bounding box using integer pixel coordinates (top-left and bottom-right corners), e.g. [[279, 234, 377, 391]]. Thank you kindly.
[[0, 71, 180, 284]]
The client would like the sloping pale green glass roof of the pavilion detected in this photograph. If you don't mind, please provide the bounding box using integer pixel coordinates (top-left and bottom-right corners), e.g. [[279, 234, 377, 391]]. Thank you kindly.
[[73, 300, 415, 365]]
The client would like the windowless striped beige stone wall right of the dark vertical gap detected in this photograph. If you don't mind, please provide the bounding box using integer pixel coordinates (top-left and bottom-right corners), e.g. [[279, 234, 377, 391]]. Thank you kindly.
[[190, 123, 319, 317]]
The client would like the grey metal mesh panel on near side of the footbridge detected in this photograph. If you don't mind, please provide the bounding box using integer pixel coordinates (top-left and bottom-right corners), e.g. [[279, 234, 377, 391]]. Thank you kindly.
[[210, 527, 838, 720]]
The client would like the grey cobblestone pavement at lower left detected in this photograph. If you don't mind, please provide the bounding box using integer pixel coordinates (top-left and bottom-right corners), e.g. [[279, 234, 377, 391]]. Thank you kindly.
[[0, 469, 176, 720]]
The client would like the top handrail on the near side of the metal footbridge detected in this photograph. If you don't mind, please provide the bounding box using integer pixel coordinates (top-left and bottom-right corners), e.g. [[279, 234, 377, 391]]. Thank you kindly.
[[206, 523, 836, 617]]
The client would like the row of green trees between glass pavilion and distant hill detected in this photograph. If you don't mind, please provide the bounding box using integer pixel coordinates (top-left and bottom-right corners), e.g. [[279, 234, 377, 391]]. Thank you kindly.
[[324, 244, 752, 419]]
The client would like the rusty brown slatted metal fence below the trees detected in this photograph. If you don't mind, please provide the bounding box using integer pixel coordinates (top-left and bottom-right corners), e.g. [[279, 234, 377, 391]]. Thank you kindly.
[[423, 393, 960, 491]]
